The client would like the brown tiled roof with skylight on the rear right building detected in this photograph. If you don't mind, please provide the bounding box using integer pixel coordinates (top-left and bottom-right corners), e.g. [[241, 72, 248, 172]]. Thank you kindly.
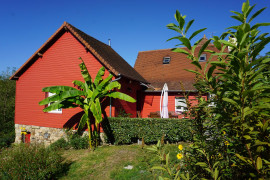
[[134, 39, 220, 91]]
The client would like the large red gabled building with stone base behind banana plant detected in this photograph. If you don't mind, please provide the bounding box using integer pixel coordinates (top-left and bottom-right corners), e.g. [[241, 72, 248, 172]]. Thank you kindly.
[[10, 22, 148, 143]]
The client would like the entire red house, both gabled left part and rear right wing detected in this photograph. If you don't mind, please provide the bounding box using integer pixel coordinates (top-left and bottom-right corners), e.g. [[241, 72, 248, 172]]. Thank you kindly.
[[10, 22, 219, 143]]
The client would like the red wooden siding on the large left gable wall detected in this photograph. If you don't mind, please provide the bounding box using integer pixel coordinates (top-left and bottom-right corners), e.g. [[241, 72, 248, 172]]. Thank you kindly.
[[15, 32, 137, 128]]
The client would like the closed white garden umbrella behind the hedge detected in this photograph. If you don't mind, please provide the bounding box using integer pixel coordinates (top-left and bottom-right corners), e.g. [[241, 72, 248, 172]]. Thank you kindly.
[[160, 83, 169, 118]]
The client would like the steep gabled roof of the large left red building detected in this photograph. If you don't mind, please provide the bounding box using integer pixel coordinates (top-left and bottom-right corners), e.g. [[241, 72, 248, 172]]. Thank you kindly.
[[10, 22, 148, 83]]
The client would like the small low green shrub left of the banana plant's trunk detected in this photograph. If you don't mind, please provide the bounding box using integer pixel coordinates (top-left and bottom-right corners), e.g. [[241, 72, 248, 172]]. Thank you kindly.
[[69, 134, 89, 149]]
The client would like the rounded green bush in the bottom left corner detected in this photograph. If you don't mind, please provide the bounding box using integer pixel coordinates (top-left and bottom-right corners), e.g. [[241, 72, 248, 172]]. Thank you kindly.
[[0, 144, 64, 179]]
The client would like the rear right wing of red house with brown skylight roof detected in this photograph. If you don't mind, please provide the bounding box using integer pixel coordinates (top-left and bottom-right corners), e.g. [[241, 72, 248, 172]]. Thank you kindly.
[[134, 37, 217, 118]]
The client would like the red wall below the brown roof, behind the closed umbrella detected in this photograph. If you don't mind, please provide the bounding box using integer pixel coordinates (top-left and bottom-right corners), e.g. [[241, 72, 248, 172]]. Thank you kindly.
[[141, 92, 207, 118]]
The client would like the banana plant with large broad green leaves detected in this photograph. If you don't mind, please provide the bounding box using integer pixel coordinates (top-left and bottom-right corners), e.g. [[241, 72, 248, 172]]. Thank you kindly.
[[39, 58, 136, 149]]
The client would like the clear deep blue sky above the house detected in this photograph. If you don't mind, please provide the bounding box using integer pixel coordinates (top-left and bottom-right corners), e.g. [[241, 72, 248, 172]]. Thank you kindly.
[[0, 0, 270, 72]]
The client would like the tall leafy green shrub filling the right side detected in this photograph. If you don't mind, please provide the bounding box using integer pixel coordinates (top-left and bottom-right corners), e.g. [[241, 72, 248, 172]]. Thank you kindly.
[[167, 0, 270, 179]]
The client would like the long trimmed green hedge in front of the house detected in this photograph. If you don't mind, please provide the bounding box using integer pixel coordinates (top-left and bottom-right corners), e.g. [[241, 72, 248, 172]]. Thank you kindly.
[[102, 117, 192, 144]]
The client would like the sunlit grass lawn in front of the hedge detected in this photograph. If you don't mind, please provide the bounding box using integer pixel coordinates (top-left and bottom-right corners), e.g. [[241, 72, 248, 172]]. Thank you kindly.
[[57, 145, 182, 180]]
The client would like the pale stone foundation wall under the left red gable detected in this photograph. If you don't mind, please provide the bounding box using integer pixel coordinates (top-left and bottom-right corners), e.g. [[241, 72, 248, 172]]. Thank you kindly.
[[15, 124, 105, 145]]
